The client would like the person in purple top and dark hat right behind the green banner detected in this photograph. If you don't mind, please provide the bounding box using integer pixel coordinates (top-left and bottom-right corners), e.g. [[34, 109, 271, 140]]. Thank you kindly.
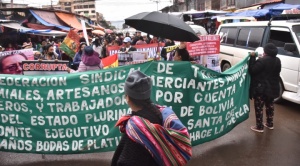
[[68, 46, 103, 73]]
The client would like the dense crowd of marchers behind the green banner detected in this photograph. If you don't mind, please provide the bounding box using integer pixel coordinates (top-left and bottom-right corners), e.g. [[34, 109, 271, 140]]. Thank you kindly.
[[0, 31, 198, 74]]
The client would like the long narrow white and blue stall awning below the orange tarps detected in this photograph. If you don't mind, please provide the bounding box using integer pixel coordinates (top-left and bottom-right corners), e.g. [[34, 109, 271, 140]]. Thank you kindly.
[[0, 22, 67, 36]]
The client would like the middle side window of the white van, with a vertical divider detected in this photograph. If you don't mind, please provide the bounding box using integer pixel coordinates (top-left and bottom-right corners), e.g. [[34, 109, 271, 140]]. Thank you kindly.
[[236, 28, 264, 48]]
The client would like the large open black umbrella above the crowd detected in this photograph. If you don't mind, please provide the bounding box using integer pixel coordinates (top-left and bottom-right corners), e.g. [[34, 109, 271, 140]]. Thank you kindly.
[[125, 12, 199, 42]]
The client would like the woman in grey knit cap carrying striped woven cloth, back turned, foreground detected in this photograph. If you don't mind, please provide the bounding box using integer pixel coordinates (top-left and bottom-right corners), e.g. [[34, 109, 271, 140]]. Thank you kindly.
[[111, 70, 192, 166]]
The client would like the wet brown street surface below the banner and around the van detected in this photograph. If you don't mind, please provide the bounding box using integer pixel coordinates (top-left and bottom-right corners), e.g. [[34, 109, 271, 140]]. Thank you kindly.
[[0, 101, 300, 166]]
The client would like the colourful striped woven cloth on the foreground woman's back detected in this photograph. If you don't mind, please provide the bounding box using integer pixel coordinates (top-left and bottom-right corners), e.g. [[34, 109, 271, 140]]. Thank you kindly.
[[116, 106, 192, 166]]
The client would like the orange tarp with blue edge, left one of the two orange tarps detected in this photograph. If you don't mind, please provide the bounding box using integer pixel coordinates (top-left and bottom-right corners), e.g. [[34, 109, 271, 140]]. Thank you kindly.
[[30, 10, 70, 31]]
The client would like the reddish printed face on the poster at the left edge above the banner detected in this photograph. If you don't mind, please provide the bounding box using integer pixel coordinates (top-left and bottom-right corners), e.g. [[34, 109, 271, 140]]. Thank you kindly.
[[0, 53, 28, 75]]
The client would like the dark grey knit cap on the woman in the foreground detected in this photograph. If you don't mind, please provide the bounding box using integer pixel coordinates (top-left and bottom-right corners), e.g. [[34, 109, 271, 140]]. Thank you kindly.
[[125, 70, 151, 100]]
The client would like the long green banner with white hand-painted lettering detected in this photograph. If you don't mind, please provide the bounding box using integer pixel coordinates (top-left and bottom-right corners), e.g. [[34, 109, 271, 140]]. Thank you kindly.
[[0, 56, 250, 154]]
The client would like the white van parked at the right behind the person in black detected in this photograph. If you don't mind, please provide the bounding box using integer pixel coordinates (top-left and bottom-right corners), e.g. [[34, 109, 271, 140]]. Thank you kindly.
[[217, 20, 300, 104]]
